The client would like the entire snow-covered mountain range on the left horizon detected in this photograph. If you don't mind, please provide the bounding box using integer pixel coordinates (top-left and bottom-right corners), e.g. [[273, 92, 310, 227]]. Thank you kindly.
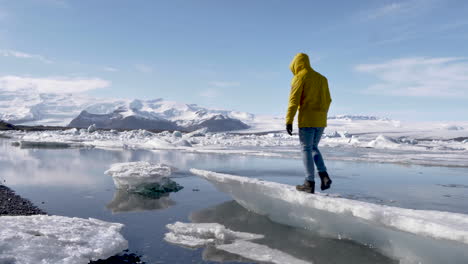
[[0, 90, 255, 131]]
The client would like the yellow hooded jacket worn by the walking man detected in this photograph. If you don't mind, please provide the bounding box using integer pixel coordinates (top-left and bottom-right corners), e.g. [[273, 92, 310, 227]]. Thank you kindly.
[[286, 53, 332, 127]]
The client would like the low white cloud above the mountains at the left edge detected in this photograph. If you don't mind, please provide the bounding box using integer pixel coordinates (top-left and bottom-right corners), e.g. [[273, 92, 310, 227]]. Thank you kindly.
[[0, 75, 111, 93]]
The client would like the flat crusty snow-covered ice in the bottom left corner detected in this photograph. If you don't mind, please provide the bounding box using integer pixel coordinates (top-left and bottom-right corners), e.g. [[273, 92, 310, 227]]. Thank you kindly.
[[0, 215, 128, 264]]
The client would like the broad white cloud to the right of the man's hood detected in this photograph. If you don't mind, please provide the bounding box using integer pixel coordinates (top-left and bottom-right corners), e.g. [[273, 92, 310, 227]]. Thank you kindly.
[[355, 57, 468, 97]]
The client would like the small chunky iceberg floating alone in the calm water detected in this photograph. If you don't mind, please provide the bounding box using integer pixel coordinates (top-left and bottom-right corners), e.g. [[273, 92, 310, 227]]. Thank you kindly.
[[104, 161, 182, 196]]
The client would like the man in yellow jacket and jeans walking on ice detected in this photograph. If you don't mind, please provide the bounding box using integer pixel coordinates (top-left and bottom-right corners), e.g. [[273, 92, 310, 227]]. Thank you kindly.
[[286, 53, 332, 193]]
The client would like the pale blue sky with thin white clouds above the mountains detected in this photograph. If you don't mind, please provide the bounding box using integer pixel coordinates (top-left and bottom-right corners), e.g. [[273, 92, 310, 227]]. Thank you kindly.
[[0, 0, 468, 121]]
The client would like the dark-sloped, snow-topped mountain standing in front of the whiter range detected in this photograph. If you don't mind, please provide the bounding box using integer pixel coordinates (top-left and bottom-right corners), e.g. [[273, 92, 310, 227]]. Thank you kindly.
[[68, 99, 253, 132]]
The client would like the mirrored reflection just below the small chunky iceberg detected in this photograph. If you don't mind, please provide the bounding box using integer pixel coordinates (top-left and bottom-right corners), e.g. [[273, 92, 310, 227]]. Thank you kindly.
[[106, 190, 175, 213]]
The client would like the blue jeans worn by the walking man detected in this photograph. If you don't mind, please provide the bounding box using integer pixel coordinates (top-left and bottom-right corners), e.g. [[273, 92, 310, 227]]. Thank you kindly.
[[299, 127, 327, 181]]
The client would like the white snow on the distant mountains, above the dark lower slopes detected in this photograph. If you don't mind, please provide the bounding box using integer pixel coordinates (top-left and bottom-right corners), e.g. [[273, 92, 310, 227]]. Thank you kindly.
[[0, 88, 254, 129]]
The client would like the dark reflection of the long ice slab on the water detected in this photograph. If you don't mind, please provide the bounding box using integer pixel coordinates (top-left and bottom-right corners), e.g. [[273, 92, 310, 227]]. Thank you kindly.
[[190, 201, 398, 263]]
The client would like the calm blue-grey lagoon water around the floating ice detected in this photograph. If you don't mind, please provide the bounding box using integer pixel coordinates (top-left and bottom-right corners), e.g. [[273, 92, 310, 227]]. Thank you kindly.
[[0, 139, 468, 263]]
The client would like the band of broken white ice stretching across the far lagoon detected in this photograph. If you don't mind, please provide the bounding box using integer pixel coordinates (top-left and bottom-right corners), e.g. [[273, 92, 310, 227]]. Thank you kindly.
[[0, 116, 468, 167]]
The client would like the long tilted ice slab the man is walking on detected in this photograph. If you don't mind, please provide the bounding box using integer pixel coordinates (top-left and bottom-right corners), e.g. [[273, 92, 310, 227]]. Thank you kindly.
[[191, 169, 468, 263]]
